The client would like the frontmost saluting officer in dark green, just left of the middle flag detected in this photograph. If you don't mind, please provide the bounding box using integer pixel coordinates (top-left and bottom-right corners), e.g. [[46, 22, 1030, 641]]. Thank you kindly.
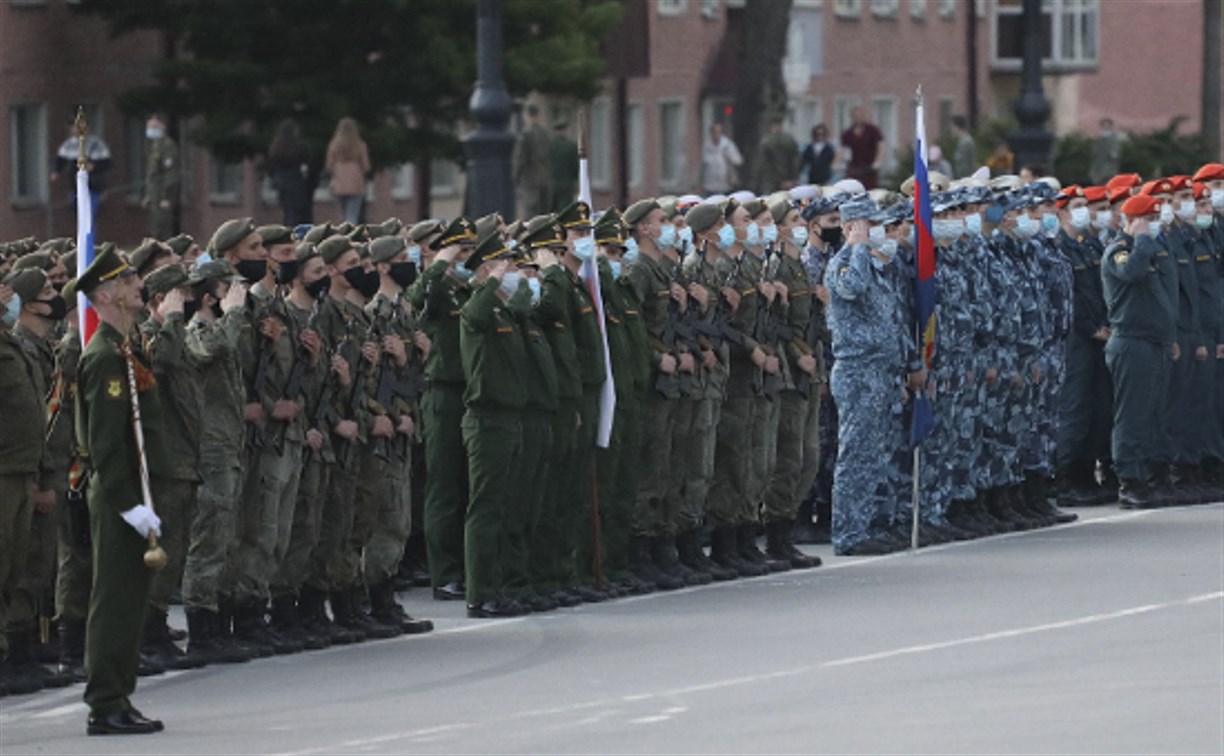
[[459, 234, 529, 618]]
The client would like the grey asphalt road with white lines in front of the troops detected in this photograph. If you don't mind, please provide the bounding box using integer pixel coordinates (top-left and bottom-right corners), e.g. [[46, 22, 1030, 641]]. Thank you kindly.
[[0, 504, 1224, 756]]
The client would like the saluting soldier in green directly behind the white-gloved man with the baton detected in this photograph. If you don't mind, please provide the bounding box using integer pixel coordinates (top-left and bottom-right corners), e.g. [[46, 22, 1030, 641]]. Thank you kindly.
[[140, 264, 207, 669]]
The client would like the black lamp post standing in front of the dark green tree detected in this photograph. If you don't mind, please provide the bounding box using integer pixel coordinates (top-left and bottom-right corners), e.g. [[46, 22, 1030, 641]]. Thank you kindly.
[[464, 0, 514, 218]]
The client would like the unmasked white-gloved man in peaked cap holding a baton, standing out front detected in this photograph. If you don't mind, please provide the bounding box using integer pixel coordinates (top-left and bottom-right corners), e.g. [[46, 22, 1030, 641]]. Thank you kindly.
[[76, 250, 166, 735]]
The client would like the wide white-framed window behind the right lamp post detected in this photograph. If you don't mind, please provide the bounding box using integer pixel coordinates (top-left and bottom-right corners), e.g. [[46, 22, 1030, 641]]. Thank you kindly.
[[991, 0, 1100, 73]]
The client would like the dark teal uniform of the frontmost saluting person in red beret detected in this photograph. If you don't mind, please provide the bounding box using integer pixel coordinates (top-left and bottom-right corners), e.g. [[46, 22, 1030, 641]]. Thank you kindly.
[[1100, 227, 1177, 489]]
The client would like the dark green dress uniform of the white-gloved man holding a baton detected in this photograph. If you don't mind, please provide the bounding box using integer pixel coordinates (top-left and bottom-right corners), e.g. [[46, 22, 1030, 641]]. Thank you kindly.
[[77, 323, 166, 717]]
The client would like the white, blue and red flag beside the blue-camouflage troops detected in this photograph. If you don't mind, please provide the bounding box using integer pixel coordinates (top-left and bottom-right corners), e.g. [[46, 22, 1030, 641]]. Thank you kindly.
[[909, 93, 935, 447]]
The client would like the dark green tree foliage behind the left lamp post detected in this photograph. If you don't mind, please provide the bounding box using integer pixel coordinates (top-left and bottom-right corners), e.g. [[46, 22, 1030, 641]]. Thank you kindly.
[[76, 0, 622, 207]]
